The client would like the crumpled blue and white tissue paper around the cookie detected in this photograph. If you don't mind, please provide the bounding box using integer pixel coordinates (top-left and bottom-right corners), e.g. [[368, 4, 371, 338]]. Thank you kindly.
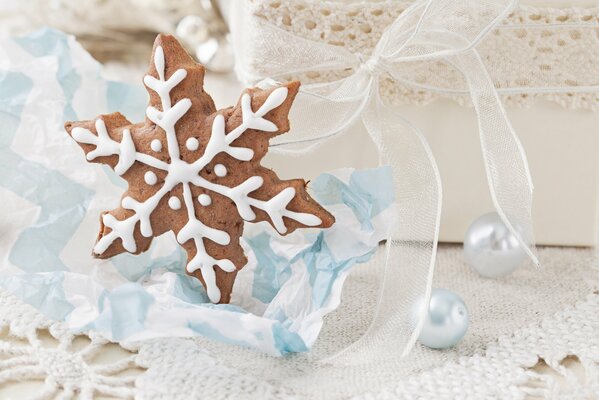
[[0, 30, 394, 355]]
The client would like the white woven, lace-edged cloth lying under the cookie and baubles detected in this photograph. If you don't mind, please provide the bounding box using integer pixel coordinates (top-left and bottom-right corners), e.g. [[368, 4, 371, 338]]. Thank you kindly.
[[0, 245, 599, 399]]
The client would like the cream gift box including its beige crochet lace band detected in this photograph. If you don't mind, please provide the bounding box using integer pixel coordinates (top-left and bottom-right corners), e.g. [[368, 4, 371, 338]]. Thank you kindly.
[[230, 0, 599, 246]]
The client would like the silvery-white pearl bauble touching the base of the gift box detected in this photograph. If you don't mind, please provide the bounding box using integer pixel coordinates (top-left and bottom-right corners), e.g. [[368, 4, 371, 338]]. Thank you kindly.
[[464, 213, 527, 278]]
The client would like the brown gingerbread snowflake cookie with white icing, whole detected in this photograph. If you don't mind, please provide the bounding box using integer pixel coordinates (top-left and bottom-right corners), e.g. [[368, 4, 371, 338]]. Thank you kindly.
[[65, 35, 334, 303]]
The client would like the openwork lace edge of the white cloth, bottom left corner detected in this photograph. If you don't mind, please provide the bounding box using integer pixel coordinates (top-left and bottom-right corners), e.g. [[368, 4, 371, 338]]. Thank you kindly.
[[0, 291, 138, 400]]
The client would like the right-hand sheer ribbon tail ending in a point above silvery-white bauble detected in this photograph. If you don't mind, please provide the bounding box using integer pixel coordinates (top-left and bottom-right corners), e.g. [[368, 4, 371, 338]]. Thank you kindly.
[[448, 49, 539, 266]]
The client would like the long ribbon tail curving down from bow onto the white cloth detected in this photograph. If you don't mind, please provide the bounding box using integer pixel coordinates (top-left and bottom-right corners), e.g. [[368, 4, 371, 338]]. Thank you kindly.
[[323, 84, 442, 364]]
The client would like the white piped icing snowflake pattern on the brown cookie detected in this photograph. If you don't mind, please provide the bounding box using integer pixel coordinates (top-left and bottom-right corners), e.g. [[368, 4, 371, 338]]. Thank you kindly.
[[88, 46, 322, 303]]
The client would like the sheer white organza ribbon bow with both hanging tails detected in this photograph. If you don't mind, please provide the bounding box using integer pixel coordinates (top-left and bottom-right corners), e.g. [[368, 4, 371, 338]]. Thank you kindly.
[[231, 0, 538, 362]]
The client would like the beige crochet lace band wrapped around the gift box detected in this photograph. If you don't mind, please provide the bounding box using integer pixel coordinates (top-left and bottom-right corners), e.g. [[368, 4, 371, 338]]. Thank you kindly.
[[251, 0, 599, 110]]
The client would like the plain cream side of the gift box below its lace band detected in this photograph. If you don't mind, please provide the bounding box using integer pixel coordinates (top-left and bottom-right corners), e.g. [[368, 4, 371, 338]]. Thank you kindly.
[[265, 100, 599, 246]]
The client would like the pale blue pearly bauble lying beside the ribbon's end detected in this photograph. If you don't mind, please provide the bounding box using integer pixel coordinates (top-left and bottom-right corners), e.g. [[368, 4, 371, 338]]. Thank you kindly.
[[411, 289, 468, 349]]
